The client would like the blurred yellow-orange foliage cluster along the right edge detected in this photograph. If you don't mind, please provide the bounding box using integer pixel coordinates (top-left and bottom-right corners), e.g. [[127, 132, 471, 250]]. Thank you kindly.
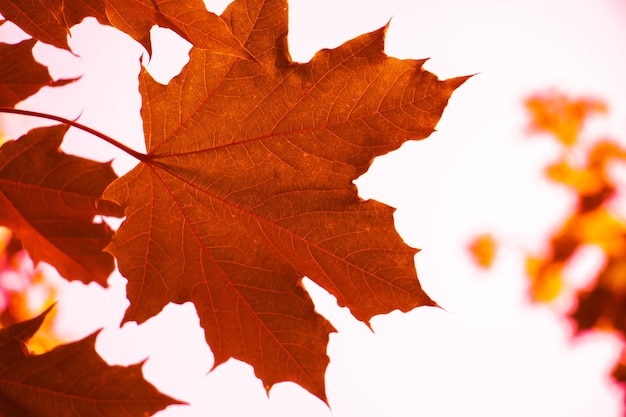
[[472, 92, 626, 402]]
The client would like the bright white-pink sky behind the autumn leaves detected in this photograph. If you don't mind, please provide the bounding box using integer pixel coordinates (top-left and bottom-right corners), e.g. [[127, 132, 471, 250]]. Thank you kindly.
[[0, 0, 626, 417]]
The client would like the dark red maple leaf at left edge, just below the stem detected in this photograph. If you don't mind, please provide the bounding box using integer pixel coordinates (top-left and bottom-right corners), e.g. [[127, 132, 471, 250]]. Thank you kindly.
[[0, 125, 122, 286]]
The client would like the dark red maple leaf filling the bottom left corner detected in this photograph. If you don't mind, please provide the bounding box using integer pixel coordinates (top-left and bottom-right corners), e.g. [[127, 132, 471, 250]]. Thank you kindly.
[[0, 308, 183, 417]]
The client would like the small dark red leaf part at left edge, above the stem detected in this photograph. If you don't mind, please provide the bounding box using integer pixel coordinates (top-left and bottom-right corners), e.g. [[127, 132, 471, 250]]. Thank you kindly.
[[0, 40, 75, 107]]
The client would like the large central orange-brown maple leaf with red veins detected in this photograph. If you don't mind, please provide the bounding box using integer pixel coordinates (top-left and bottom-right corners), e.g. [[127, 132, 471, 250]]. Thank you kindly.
[[103, 0, 467, 400]]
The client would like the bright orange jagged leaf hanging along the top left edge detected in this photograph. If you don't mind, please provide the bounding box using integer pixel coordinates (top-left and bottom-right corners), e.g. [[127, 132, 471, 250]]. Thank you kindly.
[[0, 0, 251, 59]]
